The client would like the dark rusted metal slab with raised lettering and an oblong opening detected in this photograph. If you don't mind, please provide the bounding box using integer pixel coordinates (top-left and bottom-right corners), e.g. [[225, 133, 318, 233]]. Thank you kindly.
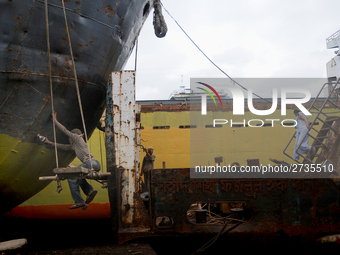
[[120, 169, 340, 245]]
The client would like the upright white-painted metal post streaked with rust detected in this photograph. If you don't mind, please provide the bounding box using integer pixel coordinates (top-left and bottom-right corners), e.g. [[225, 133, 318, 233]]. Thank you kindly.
[[107, 71, 150, 232]]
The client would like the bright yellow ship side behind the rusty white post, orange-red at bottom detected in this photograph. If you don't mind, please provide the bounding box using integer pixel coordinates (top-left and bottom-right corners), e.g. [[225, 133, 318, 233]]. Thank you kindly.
[[7, 103, 332, 218]]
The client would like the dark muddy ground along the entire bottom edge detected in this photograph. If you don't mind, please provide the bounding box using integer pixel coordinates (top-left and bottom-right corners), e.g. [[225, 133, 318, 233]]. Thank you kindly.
[[0, 217, 340, 255]]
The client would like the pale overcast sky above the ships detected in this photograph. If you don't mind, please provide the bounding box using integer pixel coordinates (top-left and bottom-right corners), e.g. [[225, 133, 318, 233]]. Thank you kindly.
[[124, 0, 340, 100]]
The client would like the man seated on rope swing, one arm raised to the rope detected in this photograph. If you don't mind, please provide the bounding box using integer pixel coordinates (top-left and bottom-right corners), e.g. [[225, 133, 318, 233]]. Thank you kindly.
[[44, 112, 100, 209]]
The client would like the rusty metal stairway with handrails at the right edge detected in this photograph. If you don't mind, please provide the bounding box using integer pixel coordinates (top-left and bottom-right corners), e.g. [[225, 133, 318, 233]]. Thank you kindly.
[[283, 78, 340, 164]]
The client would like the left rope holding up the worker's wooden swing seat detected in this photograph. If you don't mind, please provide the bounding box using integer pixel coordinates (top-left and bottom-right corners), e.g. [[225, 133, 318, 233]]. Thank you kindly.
[[45, 0, 62, 193]]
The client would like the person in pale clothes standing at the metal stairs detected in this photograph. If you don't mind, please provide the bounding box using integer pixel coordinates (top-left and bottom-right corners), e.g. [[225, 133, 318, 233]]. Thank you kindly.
[[293, 110, 315, 160]]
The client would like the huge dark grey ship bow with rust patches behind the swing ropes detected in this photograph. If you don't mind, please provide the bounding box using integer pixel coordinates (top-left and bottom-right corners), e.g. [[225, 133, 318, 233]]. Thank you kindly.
[[0, 0, 152, 214]]
